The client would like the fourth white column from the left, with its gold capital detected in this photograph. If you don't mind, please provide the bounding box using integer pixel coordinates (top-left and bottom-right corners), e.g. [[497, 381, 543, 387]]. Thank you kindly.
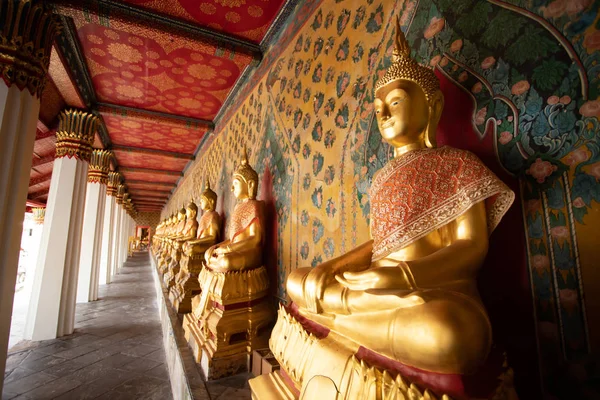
[[99, 172, 121, 285]]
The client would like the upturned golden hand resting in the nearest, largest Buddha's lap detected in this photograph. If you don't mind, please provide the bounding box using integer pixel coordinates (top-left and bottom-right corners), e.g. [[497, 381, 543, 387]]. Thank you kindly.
[[335, 262, 413, 291]]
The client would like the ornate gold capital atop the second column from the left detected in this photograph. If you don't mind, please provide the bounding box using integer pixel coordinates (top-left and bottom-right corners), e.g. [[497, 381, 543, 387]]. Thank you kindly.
[[56, 109, 99, 162]]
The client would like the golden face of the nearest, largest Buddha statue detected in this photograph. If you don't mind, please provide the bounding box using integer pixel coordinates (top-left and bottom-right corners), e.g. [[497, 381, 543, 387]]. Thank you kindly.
[[374, 80, 429, 147]]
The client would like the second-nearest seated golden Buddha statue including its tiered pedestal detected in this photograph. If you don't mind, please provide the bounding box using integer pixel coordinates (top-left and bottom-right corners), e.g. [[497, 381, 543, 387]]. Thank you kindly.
[[183, 151, 273, 379]]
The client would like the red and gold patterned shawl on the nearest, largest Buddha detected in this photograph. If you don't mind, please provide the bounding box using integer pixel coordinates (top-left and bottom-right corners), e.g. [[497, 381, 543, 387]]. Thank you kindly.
[[370, 146, 515, 261]]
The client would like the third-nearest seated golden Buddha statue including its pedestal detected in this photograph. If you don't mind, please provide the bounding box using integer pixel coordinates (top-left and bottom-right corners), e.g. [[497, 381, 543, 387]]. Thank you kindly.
[[169, 184, 221, 313]]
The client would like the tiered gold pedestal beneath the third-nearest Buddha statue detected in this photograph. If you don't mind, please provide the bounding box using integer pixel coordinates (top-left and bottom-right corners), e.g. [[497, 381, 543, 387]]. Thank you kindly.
[[169, 252, 204, 314]]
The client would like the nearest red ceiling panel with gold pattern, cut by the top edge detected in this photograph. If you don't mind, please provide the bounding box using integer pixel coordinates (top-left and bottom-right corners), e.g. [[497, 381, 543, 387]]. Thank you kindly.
[[120, 0, 284, 43]]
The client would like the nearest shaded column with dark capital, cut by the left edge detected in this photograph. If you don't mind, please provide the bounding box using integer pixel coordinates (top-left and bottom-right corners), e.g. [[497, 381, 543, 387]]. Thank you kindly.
[[0, 0, 58, 392]]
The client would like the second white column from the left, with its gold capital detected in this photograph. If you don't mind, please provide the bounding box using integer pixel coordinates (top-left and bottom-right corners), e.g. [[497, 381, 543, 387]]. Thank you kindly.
[[25, 110, 98, 340]]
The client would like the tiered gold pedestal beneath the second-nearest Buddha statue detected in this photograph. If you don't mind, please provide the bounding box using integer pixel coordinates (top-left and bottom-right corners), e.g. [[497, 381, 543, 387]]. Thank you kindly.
[[183, 267, 273, 379]]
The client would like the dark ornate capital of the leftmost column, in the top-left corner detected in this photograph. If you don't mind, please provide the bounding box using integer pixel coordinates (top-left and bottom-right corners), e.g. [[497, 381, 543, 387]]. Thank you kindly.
[[0, 0, 61, 98]]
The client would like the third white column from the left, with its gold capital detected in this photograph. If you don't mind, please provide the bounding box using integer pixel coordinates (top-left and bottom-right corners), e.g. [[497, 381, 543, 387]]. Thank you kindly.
[[77, 150, 112, 303]]
